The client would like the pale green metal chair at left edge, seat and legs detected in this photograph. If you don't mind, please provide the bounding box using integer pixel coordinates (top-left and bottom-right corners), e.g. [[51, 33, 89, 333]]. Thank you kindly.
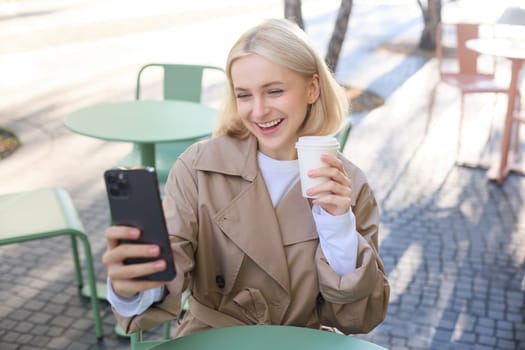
[[0, 188, 103, 340]]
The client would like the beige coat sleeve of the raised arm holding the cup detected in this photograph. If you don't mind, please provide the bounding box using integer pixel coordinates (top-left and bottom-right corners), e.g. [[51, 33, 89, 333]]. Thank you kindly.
[[316, 170, 390, 334]]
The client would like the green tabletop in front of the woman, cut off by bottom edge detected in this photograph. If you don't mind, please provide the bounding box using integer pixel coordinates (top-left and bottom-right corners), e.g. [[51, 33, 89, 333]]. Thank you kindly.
[[147, 326, 385, 350]]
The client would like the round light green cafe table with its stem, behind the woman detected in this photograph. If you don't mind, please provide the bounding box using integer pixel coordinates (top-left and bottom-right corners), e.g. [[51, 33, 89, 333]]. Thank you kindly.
[[64, 100, 216, 166]]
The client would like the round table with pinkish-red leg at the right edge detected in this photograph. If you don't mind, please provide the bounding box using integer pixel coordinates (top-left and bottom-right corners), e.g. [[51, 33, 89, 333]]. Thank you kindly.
[[467, 38, 525, 184]]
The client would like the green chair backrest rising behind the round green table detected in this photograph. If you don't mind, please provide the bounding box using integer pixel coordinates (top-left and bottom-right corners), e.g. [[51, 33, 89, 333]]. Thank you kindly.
[[135, 63, 224, 102]]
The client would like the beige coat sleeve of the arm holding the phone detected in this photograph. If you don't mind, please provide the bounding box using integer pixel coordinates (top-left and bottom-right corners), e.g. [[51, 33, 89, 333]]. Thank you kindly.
[[113, 150, 197, 334]]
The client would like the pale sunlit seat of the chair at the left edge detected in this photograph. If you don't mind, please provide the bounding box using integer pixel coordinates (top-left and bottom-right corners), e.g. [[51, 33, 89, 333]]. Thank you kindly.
[[0, 188, 84, 244]]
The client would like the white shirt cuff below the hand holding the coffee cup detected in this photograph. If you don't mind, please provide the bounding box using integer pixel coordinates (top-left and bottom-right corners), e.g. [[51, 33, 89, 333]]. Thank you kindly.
[[312, 205, 358, 276]]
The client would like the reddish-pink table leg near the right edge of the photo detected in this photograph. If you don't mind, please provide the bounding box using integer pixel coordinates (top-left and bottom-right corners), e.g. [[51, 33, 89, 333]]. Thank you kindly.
[[488, 59, 523, 185]]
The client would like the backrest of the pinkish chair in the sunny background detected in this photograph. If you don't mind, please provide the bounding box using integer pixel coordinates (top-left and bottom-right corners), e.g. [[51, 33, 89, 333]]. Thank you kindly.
[[436, 23, 490, 75]]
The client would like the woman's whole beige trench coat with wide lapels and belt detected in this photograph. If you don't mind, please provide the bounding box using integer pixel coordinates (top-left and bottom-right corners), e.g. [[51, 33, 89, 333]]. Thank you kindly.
[[115, 136, 390, 335]]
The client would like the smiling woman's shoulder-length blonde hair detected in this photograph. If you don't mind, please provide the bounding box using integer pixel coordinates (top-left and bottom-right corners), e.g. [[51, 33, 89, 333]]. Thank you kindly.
[[215, 19, 348, 138]]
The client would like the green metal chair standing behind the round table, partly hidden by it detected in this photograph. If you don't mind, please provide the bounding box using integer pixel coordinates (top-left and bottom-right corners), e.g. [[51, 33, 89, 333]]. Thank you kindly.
[[120, 63, 224, 183]]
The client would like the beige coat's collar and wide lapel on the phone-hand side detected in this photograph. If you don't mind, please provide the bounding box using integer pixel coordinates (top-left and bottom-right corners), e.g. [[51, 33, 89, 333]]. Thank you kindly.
[[195, 136, 290, 293]]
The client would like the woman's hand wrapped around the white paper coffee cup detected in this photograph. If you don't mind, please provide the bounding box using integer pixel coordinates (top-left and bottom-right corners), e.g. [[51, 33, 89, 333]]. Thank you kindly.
[[307, 154, 352, 216]]
